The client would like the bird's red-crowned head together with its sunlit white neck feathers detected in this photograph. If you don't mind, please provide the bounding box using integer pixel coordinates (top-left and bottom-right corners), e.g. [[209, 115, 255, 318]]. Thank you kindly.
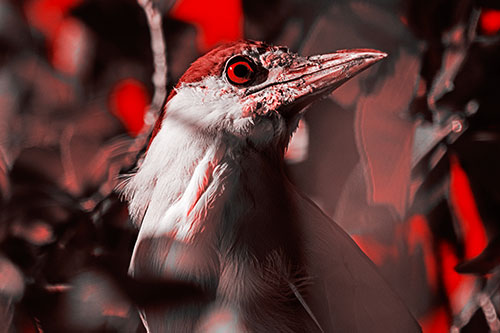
[[123, 41, 386, 236]]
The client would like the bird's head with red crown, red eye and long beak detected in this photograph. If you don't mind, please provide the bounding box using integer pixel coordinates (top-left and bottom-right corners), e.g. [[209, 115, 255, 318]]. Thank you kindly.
[[152, 41, 386, 148]]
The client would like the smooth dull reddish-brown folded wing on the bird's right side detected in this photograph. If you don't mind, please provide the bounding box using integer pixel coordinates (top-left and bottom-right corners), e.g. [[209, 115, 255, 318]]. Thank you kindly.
[[294, 191, 421, 333]]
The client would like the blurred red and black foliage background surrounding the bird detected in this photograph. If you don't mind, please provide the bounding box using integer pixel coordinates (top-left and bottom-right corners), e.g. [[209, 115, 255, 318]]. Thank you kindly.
[[0, 0, 500, 332]]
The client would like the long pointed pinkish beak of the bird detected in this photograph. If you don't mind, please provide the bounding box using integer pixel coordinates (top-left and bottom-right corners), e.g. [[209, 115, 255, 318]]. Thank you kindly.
[[246, 49, 387, 115]]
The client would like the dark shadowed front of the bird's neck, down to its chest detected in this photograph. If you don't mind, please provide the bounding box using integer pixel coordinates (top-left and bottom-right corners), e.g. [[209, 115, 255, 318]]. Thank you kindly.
[[211, 144, 307, 331]]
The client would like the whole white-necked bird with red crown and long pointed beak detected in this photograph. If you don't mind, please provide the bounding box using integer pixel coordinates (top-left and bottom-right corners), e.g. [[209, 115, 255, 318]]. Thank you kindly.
[[125, 42, 418, 332]]
